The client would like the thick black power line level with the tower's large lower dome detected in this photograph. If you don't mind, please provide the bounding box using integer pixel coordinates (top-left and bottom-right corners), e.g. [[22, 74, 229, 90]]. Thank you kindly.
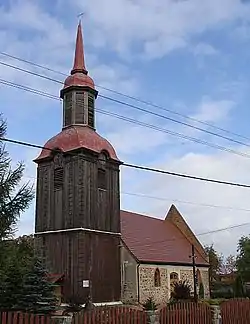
[[0, 138, 250, 188]]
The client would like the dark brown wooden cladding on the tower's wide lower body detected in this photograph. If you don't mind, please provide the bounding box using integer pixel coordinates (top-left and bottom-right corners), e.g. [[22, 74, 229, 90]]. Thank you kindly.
[[35, 150, 121, 302]]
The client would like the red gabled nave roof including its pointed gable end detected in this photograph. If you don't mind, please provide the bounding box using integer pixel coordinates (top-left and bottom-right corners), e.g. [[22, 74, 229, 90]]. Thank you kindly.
[[121, 206, 209, 266]]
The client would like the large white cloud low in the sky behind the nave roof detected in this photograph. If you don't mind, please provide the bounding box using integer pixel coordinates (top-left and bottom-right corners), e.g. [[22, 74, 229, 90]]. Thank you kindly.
[[126, 147, 250, 254]]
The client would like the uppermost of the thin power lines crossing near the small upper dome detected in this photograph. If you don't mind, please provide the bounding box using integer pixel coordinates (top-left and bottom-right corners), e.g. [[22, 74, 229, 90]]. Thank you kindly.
[[0, 52, 250, 141]]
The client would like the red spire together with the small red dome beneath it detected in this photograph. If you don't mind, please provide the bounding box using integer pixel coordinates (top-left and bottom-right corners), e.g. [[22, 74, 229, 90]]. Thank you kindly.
[[63, 22, 95, 90]]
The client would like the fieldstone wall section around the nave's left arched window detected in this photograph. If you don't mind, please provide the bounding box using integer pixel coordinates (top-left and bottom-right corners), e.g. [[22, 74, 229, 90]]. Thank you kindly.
[[139, 265, 168, 304]]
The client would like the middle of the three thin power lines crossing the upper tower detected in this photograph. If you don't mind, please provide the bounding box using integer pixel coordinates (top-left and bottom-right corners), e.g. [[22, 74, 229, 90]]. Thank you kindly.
[[0, 61, 250, 147]]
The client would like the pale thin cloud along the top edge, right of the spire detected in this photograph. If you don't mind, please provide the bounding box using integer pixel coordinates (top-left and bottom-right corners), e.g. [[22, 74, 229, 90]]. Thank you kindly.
[[74, 0, 249, 58]]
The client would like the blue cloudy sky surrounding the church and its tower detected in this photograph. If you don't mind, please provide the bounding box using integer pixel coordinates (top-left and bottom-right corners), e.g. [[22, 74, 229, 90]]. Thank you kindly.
[[0, 0, 250, 255]]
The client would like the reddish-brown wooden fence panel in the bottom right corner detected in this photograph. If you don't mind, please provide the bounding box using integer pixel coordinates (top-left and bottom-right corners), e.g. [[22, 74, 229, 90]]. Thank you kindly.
[[220, 298, 250, 324]]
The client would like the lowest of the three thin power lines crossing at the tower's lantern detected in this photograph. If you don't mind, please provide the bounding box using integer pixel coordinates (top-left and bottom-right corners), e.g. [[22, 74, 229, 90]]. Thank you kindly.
[[0, 79, 250, 158]]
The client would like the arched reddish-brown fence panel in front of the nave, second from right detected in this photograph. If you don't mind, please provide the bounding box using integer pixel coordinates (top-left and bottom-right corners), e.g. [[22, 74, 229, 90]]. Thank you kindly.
[[160, 302, 212, 324]]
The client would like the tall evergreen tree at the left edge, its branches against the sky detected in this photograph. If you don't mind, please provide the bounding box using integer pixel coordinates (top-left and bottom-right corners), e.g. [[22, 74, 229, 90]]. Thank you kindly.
[[0, 114, 34, 309]]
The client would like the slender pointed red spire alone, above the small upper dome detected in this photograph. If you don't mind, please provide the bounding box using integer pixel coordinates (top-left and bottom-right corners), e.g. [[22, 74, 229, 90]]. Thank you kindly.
[[71, 22, 88, 74]]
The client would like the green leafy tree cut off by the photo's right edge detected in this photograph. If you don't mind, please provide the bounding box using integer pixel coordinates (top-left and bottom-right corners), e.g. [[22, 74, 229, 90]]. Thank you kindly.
[[236, 236, 250, 282]]
